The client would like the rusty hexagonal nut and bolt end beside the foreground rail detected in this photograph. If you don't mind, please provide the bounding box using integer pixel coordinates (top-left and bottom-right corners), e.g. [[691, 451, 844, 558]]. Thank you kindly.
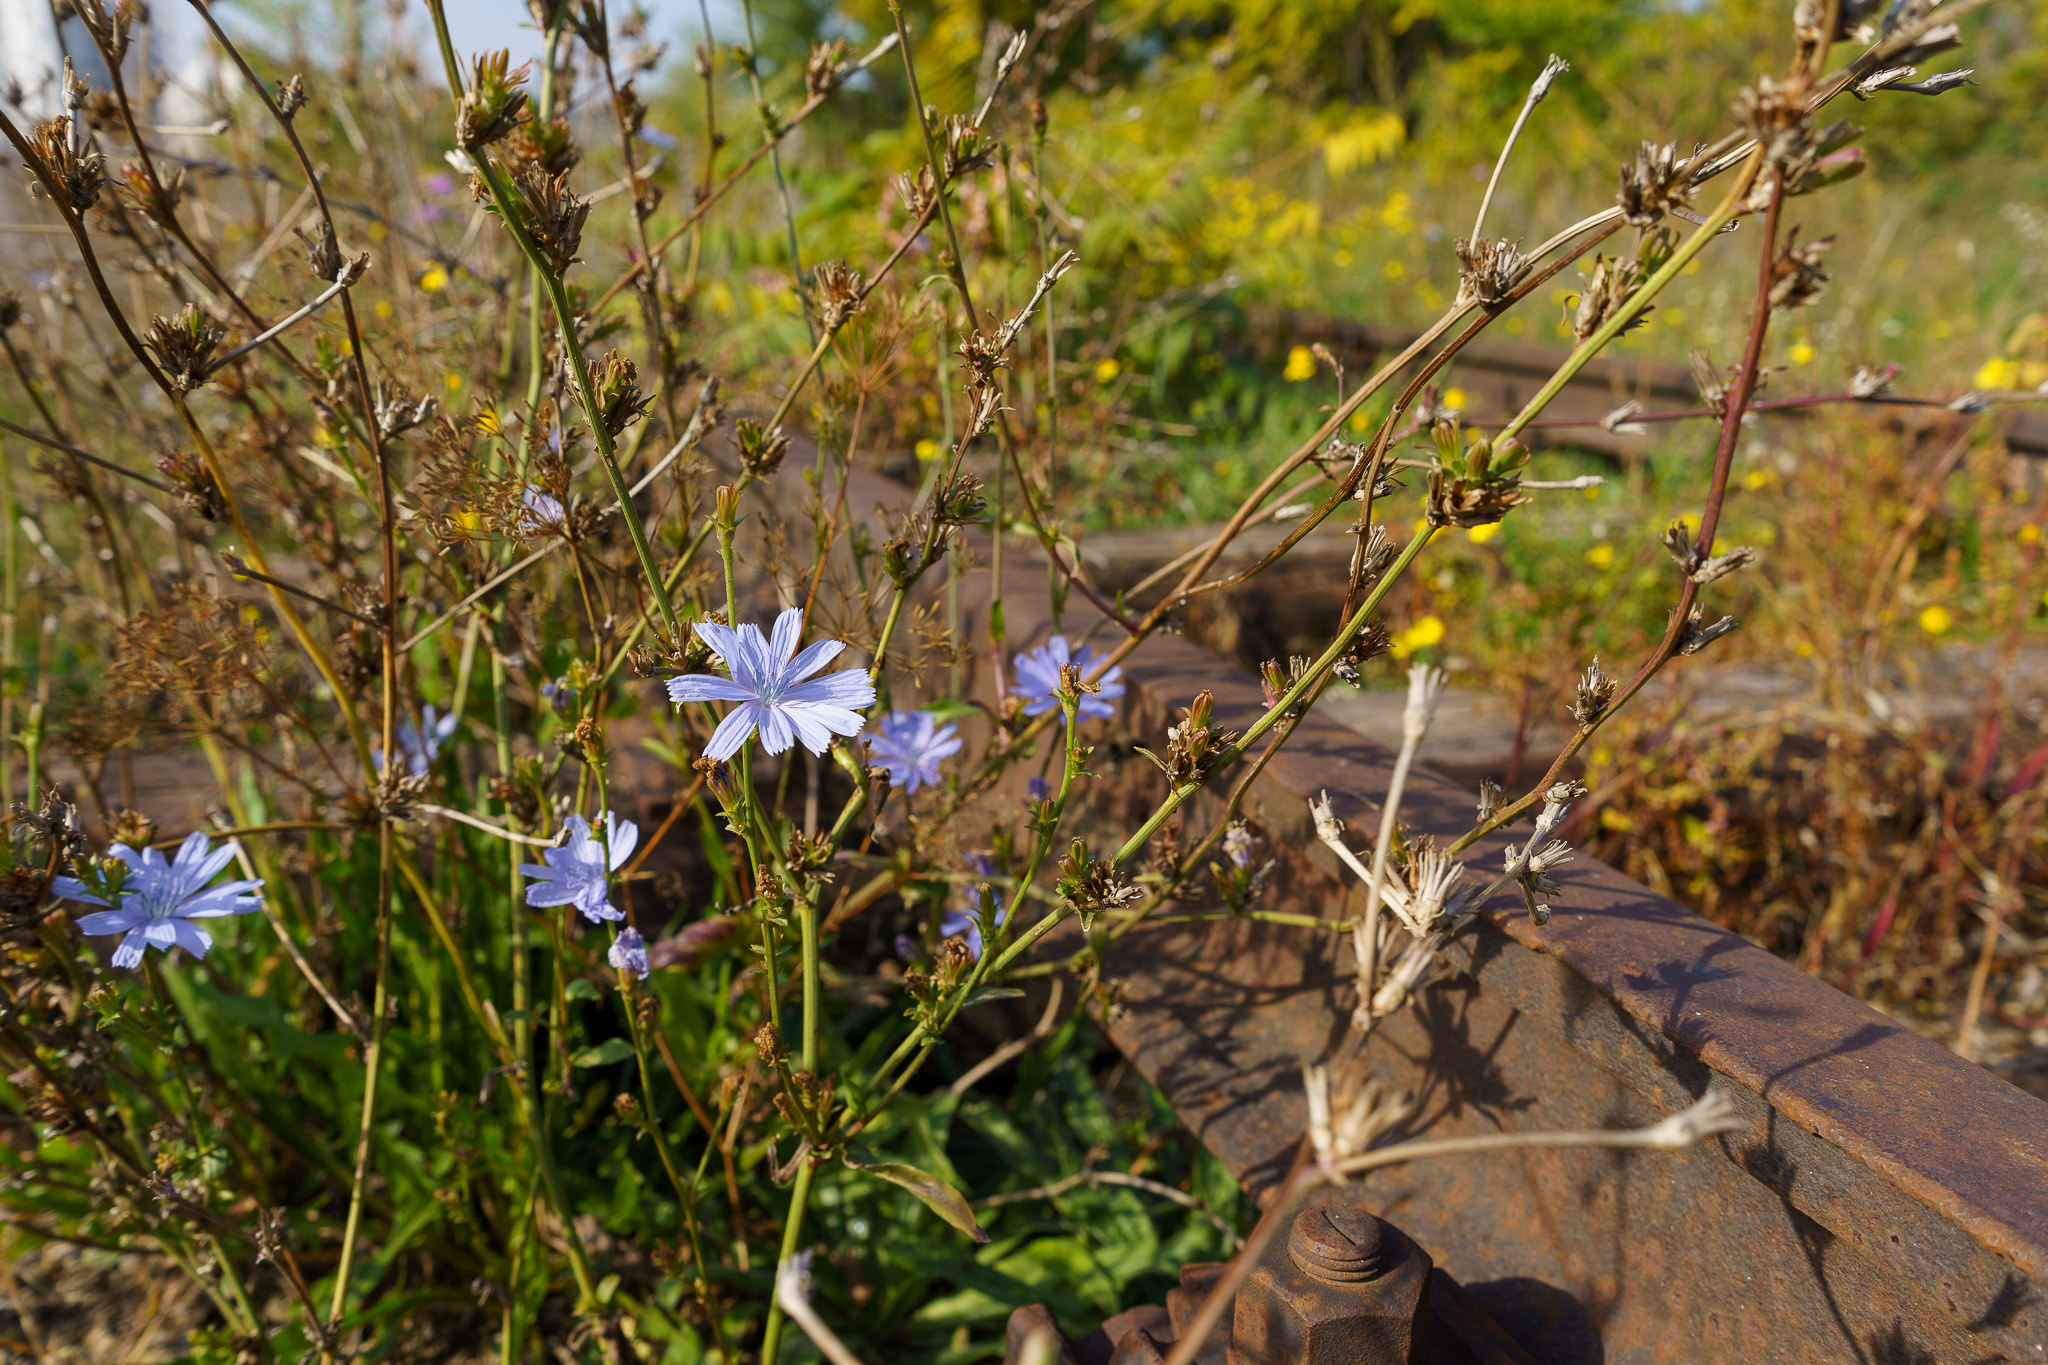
[[1229, 1203, 1430, 1365]]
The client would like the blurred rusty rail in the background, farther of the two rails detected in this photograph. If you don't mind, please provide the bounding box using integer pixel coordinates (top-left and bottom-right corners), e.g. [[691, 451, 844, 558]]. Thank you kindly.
[[1257, 313, 2048, 458]]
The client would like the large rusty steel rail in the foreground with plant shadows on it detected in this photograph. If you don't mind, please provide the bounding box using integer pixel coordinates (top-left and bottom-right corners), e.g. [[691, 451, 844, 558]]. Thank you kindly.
[[962, 544, 2048, 1363]]
